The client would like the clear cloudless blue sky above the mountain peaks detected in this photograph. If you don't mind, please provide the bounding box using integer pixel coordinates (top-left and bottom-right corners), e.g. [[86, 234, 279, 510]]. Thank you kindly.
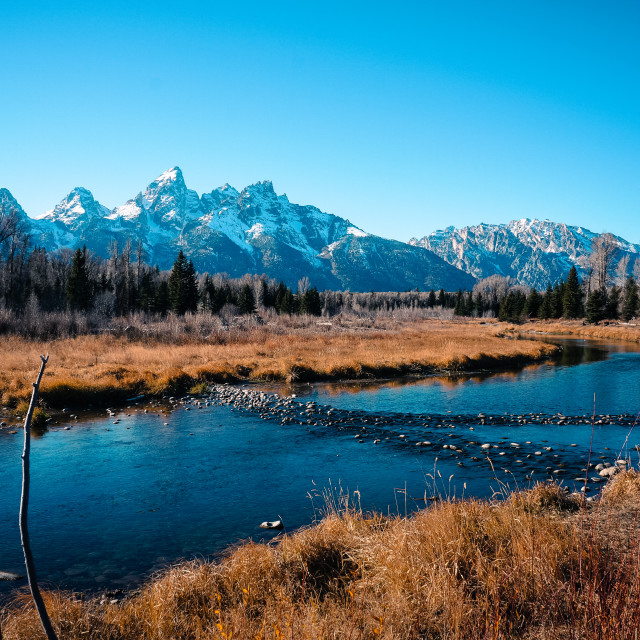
[[0, 0, 640, 242]]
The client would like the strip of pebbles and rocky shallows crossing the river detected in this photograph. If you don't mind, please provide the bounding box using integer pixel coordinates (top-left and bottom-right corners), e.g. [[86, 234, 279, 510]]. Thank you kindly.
[[191, 385, 640, 500]]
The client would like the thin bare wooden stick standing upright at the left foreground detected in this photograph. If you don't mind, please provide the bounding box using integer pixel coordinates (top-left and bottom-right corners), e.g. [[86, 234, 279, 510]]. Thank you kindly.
[[20, 355, 58, 640]]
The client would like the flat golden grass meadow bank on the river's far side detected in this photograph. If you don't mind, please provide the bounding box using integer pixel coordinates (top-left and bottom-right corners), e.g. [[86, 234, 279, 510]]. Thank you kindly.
[[0, 319, 557, 409]]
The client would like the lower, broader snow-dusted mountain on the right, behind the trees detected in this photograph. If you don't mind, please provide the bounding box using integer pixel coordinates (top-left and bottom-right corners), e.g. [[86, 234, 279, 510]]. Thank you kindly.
[[409, 218, 640, 289]]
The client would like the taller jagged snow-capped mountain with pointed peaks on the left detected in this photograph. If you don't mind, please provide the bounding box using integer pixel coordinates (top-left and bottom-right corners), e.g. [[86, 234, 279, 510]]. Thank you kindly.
[[0, 167, 475, 291]]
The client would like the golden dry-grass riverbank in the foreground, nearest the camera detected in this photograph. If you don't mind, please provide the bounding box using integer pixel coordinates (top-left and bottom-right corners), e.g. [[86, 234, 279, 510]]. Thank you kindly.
[[2, 471, 640, 640]]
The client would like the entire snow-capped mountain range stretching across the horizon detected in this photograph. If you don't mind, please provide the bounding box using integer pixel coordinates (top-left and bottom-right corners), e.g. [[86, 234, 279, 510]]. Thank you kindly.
[[0, 167, 640, 291]]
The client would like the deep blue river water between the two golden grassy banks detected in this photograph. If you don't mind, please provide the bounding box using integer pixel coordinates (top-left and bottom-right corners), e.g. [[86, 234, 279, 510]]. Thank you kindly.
[[0, 341, 640, 597]]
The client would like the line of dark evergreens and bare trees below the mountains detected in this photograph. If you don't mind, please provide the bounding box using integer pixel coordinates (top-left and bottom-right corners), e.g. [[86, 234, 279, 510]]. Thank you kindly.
[[0, 204, 640, 322]]
